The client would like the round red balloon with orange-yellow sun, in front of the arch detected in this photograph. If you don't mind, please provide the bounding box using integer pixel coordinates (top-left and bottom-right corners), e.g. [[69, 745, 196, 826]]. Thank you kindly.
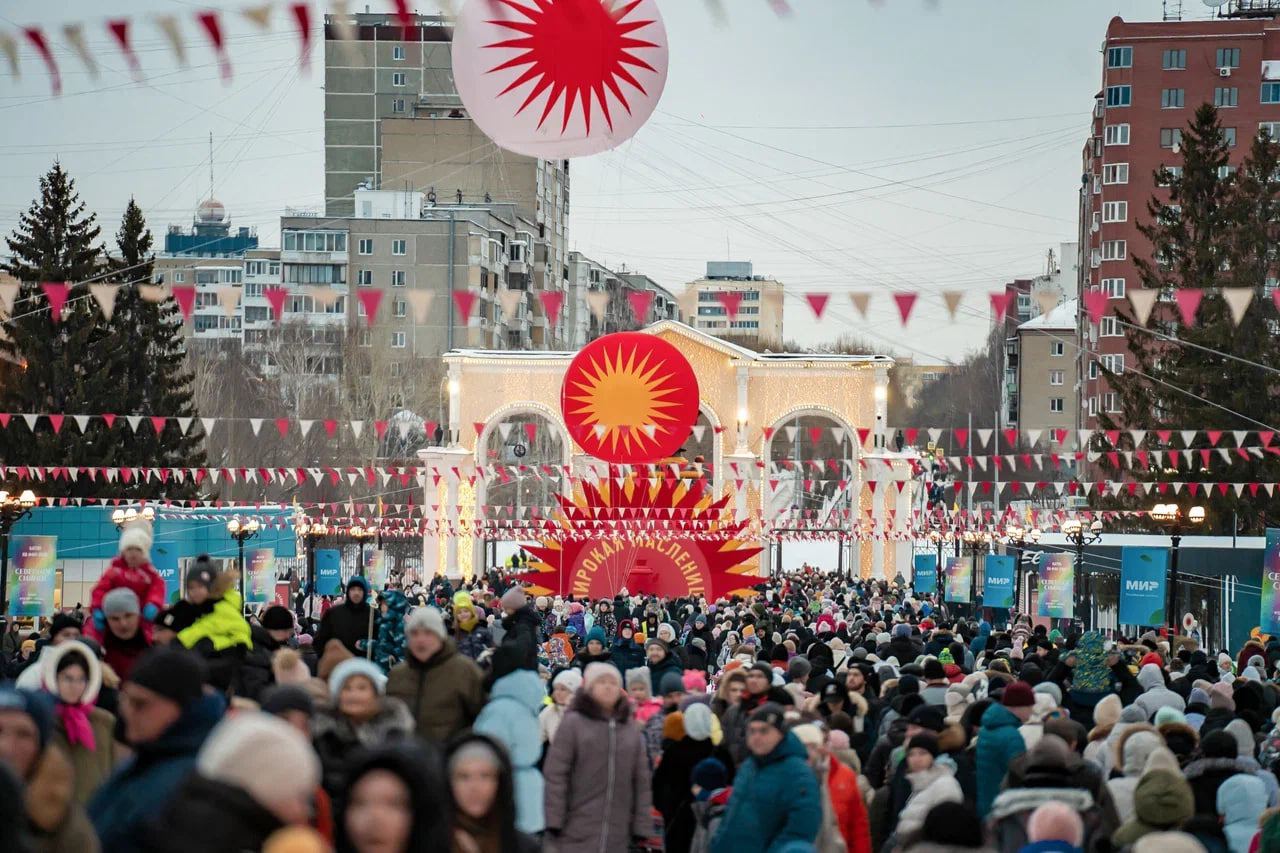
[[561, 332, 698, 464]]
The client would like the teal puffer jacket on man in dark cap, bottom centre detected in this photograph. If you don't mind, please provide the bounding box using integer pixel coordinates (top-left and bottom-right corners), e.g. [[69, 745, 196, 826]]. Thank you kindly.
[[710, 731, 822, 853]]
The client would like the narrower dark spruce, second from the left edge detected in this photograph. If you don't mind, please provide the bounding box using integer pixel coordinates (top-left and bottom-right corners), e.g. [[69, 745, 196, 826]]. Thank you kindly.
[[109, 199, 205, 498]]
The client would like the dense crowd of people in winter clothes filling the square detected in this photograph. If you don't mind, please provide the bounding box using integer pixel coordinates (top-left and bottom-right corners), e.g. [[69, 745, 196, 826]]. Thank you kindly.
[[0, 528, 1280, 853]]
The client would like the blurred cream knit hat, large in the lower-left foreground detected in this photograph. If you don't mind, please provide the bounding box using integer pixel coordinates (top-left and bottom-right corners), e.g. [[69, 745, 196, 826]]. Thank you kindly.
[[196, 711, 320, 806]]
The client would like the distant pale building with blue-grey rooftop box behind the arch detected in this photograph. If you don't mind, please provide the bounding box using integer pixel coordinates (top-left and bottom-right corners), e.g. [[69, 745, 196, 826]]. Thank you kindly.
[[680, 261, 783, 351]]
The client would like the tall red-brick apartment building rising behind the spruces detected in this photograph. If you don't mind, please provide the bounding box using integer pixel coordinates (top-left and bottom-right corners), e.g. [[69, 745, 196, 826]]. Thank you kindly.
[[1079, 8, 1280, 429]]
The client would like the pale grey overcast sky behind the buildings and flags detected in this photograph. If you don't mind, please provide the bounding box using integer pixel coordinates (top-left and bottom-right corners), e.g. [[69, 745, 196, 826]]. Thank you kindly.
[[0, 0, 1206, 361]]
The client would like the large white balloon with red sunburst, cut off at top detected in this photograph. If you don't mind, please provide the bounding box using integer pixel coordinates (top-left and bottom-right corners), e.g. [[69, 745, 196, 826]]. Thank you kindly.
[[453, 0, 667, 159]]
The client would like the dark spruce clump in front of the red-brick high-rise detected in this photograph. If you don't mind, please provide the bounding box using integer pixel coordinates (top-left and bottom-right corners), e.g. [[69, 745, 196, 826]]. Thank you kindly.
[[1093, 104, 1280, 533]]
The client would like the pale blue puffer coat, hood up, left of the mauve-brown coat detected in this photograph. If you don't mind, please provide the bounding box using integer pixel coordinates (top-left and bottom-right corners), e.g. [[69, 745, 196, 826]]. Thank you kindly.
[[472, 670, 545, 835]]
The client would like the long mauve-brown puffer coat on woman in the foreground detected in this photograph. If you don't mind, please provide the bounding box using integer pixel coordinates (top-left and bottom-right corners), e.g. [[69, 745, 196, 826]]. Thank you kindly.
[[543, 693, 653, 853]]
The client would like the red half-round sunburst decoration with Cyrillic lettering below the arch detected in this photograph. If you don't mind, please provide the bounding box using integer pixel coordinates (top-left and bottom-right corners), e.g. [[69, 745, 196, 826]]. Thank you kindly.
[[520, 466, 763, 599]]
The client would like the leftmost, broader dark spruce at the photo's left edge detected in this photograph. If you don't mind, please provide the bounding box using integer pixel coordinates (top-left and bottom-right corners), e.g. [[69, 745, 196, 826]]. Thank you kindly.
[[0, 163, 123, 497]]
